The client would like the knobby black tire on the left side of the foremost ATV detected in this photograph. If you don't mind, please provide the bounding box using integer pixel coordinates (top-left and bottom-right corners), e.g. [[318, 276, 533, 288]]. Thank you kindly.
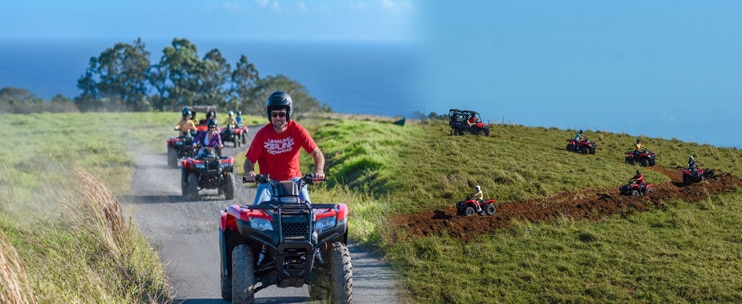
[[232, 244, 255, 304]]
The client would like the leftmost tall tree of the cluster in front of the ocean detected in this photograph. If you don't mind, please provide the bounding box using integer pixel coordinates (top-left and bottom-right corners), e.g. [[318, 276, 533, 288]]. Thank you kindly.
[[77, 38, 150, 111]]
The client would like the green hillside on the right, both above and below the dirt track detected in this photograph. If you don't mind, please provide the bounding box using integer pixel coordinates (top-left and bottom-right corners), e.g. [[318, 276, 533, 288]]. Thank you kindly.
[[318, 121, 742, 303]]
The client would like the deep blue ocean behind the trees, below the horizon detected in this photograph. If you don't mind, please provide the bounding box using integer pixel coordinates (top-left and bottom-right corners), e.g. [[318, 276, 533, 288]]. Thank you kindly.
[[0, 39, 420, 117]]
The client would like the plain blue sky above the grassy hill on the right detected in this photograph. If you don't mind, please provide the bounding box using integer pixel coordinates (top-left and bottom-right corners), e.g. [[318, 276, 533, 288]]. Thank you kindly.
[[420, 0, 742, 147]]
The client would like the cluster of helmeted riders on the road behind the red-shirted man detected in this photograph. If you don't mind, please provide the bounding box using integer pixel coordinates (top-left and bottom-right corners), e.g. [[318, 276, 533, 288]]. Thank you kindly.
[[175, 107, 242, 158]]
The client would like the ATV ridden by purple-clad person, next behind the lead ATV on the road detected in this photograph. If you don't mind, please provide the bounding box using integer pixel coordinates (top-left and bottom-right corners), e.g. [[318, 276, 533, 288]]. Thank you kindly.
[[180, 148, 235, 200]]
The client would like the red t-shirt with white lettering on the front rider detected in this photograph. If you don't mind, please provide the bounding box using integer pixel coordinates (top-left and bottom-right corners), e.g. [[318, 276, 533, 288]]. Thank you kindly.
[[245, 120, 317, 180]]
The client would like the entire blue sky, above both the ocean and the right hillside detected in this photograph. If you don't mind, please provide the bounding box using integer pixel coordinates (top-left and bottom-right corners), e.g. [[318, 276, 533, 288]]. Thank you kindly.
[[0, 0, 742, 147]]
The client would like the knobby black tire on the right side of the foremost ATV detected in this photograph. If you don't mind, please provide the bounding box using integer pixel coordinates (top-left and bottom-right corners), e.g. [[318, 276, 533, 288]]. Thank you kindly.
[[329, 242, 353, 303]]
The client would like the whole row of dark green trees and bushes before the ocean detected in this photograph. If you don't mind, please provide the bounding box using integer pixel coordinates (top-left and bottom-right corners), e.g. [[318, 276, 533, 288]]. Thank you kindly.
[[0, 38, 332, 115]]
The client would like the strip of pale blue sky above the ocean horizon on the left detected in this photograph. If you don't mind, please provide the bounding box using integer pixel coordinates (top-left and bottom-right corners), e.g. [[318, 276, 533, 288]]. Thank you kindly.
[[0, 0, 417, 41]]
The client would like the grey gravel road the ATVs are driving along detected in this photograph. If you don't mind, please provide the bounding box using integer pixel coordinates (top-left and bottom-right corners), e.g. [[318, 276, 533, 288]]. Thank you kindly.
[[119, 127, 402, 304]]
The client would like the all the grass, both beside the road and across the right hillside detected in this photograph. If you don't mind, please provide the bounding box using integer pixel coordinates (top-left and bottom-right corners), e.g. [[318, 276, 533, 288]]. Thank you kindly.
[[0, 113, 742, 303]]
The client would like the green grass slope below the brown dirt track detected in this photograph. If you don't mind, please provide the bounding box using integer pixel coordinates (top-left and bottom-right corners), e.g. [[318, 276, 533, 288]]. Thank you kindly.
[[389, 194, 742, 303]]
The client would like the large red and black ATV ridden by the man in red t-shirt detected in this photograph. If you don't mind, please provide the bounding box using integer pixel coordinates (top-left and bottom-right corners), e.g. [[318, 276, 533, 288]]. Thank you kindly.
[[219, 174, 353, 303]]
